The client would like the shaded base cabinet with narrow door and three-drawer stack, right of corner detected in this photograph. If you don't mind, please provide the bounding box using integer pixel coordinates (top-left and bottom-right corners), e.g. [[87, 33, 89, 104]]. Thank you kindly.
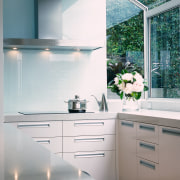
[[118, 120, 159, 180]]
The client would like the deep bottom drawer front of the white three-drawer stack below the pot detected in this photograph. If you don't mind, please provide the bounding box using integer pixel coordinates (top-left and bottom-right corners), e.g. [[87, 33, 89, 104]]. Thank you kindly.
[[63, 151, 116, 180]]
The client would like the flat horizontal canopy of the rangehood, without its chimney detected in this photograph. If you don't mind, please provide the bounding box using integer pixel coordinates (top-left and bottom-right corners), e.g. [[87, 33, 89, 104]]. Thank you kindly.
[[4, 38, 103, 51]]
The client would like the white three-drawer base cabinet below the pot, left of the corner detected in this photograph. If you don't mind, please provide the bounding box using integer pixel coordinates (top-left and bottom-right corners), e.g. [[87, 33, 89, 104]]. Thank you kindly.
[[63, 119, 117, 180]]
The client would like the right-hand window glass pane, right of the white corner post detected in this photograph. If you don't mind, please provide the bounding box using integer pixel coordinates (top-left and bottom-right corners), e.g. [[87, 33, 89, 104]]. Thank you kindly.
[[151, 7, 180, 98]]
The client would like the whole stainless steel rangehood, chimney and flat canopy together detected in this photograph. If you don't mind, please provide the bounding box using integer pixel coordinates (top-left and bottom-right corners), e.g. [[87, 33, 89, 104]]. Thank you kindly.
[[3, 0, 104, 51]]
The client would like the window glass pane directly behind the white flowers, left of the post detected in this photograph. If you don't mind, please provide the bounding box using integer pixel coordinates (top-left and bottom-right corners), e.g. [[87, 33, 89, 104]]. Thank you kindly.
[[106, 0, 144, 99]]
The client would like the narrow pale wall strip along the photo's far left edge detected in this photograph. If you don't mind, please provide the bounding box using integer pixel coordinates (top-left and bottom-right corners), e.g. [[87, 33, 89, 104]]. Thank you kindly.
[[0, 0, 3, 122]]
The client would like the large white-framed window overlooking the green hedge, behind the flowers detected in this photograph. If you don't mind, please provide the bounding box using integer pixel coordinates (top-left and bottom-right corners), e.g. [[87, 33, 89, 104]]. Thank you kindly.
[[106, 0, 180, 111]]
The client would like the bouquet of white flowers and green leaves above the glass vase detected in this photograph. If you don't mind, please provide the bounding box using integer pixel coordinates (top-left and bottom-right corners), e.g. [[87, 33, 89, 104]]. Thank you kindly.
[[108, 70, 148, 100]]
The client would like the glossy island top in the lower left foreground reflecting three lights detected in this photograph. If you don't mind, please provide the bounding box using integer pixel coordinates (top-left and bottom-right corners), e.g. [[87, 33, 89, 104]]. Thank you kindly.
[[0, 124, 93, 180]]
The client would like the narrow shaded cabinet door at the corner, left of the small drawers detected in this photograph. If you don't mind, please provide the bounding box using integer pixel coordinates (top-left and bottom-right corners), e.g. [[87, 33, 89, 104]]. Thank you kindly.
[[118, 120, 137, 180]]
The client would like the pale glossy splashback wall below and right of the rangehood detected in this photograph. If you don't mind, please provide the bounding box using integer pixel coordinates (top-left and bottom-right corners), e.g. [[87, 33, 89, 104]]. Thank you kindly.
[[4, 0, 106, 113]]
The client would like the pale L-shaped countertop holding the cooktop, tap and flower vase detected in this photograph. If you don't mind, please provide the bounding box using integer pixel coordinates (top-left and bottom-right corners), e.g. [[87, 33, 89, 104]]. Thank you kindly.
[[4, 109, 180, 128]]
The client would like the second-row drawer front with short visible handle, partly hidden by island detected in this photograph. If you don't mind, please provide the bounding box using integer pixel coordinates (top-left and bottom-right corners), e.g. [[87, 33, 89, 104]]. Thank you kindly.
[[33, 137, 62, 153]]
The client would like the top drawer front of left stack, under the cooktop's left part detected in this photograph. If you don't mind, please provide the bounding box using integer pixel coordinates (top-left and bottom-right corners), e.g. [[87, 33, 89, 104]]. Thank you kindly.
[[13, 121, 62, 138]]
